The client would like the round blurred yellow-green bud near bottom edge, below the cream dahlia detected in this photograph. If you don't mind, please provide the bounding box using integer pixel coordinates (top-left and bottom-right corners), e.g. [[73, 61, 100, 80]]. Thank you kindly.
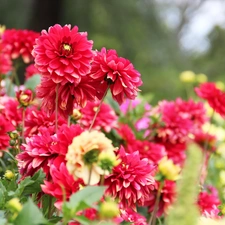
[[99, 200, 120, 219]]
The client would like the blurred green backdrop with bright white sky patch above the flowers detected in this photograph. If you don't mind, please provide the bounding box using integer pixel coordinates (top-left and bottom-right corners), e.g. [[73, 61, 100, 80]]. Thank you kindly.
[[0, 0, 225, 102]]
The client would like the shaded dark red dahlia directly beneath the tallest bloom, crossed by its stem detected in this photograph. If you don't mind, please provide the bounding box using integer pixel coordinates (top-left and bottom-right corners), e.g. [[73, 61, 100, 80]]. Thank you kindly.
[[36, 78, 96, 118]]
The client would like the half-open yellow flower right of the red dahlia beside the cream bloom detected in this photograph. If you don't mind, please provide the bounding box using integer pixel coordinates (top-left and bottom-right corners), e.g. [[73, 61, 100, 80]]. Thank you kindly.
[[158, 157, 181, 181]]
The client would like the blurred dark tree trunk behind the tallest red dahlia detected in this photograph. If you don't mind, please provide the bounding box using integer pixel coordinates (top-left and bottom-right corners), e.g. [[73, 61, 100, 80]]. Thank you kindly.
[[28, 0, 63, 31]]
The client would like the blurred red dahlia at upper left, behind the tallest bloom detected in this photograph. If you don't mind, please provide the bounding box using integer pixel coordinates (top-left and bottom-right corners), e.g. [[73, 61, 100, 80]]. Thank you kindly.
[[2, 29, 40, 63]]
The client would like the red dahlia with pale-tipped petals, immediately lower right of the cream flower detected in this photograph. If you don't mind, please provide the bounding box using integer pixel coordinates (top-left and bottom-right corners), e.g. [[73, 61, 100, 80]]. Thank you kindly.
[[105, 148, 155, 209]]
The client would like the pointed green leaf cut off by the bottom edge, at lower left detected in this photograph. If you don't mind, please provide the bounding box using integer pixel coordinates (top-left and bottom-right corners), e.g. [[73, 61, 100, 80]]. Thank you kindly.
[[14, 199, 48, 225]]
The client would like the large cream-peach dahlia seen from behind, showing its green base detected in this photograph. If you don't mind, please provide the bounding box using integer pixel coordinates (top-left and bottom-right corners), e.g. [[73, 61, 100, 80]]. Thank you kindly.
[[66, 130, 115, 185]]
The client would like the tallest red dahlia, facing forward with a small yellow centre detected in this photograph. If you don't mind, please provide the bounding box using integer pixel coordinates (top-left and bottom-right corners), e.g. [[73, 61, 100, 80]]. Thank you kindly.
[[32, 24, 93, 84]]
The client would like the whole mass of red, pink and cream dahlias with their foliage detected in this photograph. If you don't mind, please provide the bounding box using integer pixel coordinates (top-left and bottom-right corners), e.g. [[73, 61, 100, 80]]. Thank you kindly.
[[0, 24, 225, 225]]
